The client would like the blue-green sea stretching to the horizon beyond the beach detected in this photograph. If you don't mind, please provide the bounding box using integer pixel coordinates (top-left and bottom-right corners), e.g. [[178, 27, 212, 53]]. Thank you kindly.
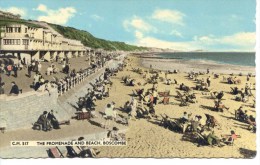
[[156, 52, 256, 66]]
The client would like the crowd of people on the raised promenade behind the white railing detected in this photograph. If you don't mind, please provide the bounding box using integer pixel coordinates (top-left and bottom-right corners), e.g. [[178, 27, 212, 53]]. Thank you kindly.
[[0, 52, 114, 94]]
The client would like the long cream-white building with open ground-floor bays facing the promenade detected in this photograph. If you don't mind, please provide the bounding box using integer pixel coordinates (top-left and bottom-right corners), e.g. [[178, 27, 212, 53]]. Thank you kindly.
[[0, 24, 91, 61]]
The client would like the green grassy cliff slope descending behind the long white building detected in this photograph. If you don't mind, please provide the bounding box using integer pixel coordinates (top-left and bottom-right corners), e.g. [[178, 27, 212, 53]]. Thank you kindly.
[[49, 24, 147, 51]]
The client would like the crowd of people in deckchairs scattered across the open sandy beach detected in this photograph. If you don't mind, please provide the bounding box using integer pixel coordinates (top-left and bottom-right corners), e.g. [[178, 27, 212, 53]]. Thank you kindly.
[[119, 60, 256, 146]]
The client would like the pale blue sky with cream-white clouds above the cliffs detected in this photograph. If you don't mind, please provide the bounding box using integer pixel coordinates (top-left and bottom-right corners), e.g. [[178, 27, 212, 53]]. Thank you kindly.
[[0, 0, 259, 51]]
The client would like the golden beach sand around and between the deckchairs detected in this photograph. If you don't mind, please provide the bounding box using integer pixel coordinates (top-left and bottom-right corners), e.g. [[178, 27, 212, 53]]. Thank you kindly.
[[94, 56, 256, 158]]
